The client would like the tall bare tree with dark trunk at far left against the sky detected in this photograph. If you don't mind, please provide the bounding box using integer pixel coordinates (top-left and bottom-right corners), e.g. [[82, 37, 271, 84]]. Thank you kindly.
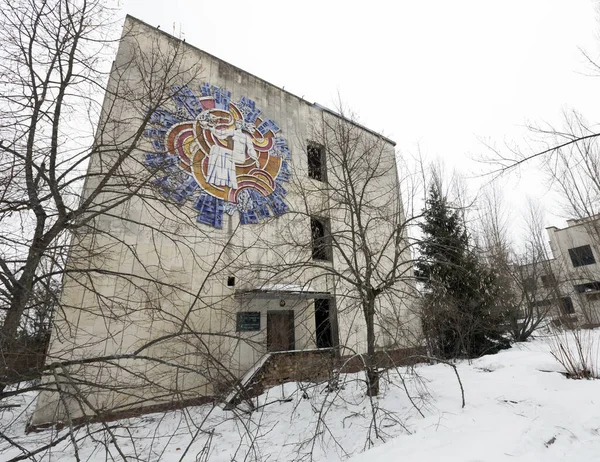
[[0, 1, 197, 360]]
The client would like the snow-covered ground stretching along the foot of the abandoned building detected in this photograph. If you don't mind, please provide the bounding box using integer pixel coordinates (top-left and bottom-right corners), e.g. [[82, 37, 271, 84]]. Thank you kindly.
[[0, 330, 600, 462]]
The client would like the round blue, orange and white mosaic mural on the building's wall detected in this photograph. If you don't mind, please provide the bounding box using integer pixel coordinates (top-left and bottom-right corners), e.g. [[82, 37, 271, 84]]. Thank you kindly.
[[145, 83, 290, 228]]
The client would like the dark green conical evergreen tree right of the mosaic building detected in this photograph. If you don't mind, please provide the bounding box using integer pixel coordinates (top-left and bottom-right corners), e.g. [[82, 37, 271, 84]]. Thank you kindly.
[[416, 185, 508, 358]]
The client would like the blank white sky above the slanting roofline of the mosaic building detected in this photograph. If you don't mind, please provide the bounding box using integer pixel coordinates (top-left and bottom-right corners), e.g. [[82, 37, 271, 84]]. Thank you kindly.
[[121, 0, 600, 236]]
